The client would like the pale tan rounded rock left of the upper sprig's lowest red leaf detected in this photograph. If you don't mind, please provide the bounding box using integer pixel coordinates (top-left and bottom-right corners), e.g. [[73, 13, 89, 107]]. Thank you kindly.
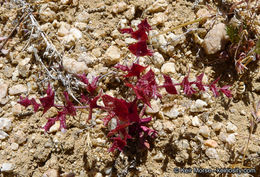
[[105, 45, 121, 64]]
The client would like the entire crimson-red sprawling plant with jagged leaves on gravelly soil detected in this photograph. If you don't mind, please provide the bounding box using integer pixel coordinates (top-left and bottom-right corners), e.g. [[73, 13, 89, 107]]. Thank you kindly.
[[19, 20, 232, 152]]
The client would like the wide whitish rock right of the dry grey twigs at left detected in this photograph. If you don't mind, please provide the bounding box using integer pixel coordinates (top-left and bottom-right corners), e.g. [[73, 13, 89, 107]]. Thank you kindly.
[[63, 57, 88, 74]]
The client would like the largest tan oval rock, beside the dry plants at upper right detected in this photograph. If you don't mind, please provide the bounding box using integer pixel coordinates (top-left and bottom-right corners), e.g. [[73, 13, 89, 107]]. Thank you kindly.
[[202, 23, 228, 54]]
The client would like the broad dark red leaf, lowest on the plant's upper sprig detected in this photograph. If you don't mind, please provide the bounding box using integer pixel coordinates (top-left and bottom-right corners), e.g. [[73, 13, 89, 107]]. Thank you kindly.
[[128, 41, 153, 57]]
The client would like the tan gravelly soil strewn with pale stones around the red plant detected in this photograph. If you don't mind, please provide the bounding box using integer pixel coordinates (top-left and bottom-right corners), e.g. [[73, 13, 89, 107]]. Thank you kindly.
[[0, 0, 260, 177]]
